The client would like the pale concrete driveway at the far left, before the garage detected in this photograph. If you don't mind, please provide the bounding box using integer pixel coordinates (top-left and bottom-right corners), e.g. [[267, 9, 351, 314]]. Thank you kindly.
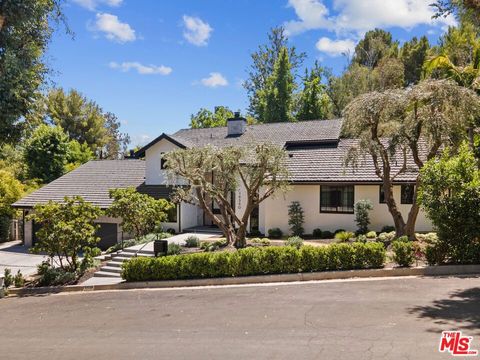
[[0, 241, 47, 276]]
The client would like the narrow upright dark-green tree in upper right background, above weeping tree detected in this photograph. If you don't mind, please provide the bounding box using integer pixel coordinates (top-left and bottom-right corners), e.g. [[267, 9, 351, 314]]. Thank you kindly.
[[400, 36, 430, 86]]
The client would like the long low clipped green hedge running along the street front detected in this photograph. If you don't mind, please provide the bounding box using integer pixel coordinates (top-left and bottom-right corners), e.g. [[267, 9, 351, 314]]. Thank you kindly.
[[122, 242, 386, 281]]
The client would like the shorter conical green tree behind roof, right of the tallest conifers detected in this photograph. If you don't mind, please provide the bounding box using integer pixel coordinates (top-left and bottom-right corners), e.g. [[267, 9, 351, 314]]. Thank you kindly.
[[295, 62, 331, 121]]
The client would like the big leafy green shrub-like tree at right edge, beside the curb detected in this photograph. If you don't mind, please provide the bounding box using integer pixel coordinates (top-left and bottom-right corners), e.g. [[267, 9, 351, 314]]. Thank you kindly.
[[419, 144, 480, 264]]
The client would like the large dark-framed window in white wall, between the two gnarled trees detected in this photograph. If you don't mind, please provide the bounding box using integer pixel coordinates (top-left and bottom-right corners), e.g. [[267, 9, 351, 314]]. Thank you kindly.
[[320, 185, 354, 214]]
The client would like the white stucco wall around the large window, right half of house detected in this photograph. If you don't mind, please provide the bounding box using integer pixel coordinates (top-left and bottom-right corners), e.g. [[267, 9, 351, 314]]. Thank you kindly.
[[260, 185, 432, 234]]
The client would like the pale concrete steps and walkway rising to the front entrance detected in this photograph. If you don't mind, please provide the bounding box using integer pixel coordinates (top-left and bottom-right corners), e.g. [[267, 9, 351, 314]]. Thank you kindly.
[[82, 233, 219, 285]]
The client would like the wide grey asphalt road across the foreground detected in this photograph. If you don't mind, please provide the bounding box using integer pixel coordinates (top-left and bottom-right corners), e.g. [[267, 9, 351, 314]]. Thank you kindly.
[[0, 277, 480, 360]]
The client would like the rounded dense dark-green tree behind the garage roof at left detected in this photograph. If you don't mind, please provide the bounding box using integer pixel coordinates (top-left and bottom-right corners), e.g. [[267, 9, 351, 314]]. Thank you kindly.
[[24, 125, 69, 183]]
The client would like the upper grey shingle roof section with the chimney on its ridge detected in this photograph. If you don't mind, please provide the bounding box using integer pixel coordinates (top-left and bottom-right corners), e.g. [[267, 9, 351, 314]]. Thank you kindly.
[[171, 119, 342, 147]]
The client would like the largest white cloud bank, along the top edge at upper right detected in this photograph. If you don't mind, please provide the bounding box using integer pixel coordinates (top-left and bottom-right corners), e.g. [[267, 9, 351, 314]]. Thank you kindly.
[[285, 0, 455, 35]]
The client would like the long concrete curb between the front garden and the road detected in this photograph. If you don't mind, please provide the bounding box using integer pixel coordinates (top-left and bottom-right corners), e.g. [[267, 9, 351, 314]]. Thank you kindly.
[[8, 265, 480, 296]]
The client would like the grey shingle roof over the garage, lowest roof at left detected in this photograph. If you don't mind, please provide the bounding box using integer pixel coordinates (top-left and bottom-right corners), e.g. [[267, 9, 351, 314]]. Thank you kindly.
[[13, 159, 145, 209]]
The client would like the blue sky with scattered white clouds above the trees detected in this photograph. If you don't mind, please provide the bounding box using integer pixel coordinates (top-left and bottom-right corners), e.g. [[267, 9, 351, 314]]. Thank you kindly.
[[47, 0, 455, 147]]
